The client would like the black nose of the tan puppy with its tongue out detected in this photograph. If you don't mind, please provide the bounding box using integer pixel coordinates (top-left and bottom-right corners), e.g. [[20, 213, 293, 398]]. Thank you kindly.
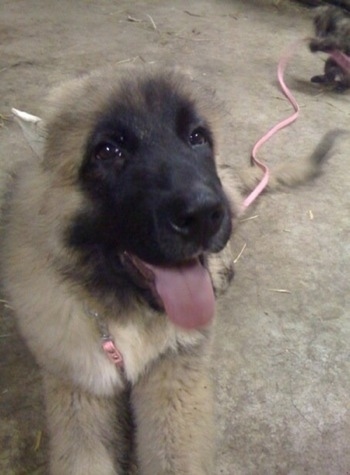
[[170, 190, 225, 244]]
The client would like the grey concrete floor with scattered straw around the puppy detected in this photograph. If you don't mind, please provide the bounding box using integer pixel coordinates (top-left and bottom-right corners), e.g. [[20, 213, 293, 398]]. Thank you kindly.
[[0, 0, 350, 475]]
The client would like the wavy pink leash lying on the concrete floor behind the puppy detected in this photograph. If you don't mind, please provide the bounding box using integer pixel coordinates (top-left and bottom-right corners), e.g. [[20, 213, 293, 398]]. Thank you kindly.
[[243, 40, 304, 209]]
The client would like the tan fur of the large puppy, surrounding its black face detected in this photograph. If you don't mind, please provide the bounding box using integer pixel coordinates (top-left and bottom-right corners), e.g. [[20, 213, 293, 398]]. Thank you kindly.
[[2, 65, 334, 475]]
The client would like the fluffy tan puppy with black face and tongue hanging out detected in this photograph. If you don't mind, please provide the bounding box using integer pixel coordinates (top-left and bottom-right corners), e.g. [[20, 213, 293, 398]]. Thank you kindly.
[[2, 68, 237, 475]]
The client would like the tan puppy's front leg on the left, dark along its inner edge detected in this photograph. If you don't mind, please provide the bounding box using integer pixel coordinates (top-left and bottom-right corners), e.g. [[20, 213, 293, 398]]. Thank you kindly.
[[44, 375, 130, 475]]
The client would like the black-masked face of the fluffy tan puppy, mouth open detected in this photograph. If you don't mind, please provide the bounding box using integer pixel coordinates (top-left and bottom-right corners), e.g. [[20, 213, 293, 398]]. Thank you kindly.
[[70, 74, 231, 327]]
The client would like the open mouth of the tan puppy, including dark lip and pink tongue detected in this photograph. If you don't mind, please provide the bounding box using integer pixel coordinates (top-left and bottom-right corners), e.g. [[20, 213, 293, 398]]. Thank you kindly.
[[122, 252, 215, 330]]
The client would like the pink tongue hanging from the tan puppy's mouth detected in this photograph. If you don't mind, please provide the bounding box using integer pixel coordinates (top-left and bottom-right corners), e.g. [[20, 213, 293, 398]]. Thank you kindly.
[[149, 260, 215, 329]]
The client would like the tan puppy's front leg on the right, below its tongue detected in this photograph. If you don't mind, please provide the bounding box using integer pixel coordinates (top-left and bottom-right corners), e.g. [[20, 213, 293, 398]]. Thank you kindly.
[[132, 348, 215, 475]]
